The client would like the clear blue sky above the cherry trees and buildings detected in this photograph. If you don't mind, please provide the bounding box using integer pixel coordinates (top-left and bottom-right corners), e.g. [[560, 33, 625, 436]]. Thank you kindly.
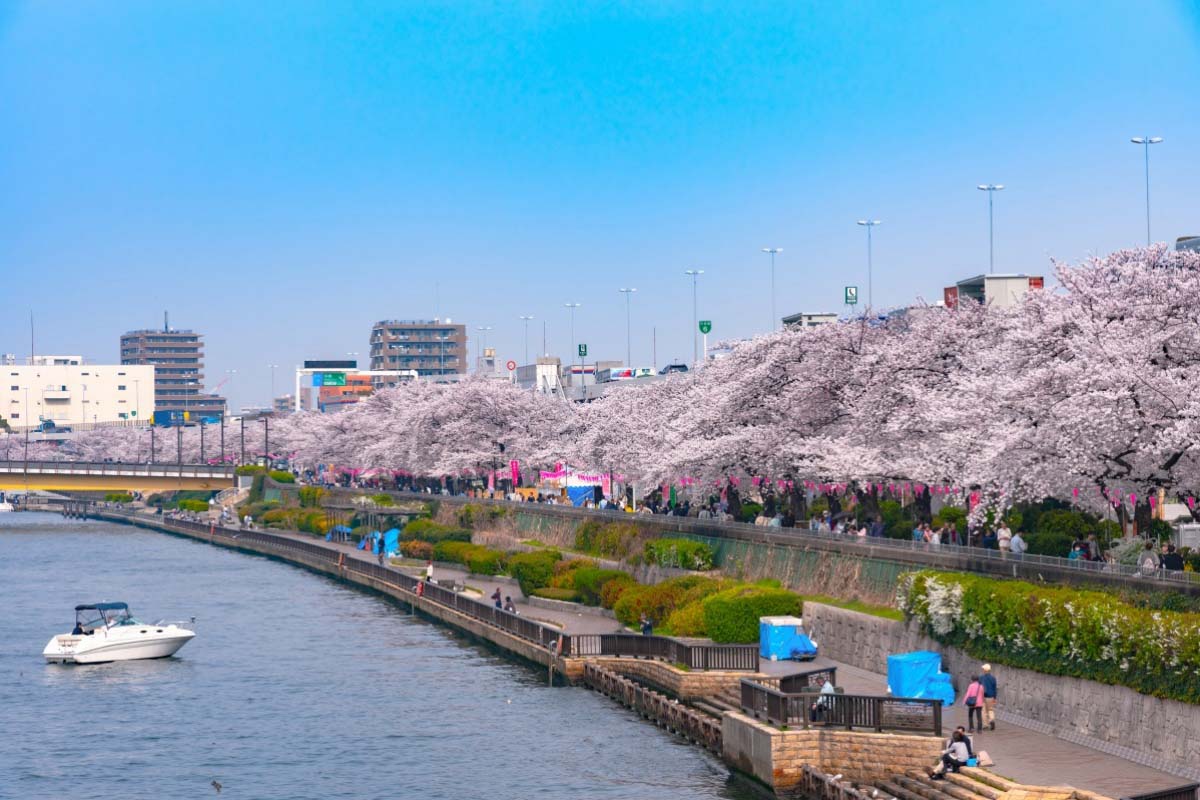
[[0, 0, 1200, 404]]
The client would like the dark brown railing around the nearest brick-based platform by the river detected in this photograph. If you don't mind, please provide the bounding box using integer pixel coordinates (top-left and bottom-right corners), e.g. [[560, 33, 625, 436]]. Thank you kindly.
[[742, 679, 942, 736]]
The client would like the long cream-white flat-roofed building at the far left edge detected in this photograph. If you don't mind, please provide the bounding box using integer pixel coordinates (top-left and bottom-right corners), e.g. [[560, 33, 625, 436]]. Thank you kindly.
[[0, 356, 155, 431]]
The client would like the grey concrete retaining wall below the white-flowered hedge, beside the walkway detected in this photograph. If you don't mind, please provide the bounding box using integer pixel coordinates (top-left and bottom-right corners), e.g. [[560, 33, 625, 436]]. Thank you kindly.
[[804, 602, 1200, 780]]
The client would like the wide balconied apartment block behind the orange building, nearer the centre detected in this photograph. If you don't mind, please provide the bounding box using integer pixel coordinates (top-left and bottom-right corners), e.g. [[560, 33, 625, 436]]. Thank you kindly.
[[371, 319, 467, 378]]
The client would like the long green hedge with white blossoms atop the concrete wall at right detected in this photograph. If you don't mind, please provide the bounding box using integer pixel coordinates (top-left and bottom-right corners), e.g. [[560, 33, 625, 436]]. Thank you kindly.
[[896, 571, 1200, 703]]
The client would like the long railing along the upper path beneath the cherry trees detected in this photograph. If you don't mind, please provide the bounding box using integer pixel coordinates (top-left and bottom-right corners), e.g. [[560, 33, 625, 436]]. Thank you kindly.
[[391, 489, 1200, 590]]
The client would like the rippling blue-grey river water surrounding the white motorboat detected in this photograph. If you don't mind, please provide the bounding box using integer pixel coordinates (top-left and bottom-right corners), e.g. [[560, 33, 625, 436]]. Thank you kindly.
[[0, 513, 758, 800]]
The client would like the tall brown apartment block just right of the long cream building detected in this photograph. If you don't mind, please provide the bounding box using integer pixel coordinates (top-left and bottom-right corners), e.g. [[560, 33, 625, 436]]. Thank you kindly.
[[121, 318, 226, 419]]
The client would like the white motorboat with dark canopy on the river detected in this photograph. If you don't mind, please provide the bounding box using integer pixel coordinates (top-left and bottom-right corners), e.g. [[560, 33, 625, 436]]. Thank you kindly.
[[42, 603, 196, 664]]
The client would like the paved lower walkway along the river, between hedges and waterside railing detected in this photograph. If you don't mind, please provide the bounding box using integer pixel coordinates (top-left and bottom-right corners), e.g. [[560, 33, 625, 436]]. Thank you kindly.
[[82, 513, 1182, 798]]
